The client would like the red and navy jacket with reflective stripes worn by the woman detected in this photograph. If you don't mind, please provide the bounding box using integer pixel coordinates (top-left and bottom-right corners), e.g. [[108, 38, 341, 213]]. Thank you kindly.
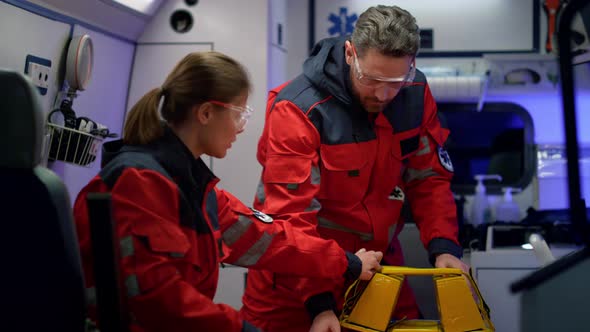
[[74, 129, 360, 331]]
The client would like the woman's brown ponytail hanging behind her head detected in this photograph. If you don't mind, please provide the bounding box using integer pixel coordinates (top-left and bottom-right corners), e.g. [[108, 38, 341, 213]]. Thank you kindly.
[[123, 88, 166, 145]]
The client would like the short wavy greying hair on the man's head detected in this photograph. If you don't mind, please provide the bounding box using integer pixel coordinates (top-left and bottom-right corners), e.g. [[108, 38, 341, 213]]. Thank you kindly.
[[352, 5, 420, 57]]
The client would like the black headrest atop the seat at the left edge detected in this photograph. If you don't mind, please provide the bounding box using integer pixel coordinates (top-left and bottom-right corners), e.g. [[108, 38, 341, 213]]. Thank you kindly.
[[0, 69, 45, 168]]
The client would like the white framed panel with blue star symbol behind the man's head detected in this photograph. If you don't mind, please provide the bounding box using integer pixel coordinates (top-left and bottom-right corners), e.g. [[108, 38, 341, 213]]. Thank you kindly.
[[315, 0, 535, 51]]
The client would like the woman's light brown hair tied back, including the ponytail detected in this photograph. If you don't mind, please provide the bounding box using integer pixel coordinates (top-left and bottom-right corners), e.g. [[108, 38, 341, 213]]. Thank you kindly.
[[123, 51, 251, 145]]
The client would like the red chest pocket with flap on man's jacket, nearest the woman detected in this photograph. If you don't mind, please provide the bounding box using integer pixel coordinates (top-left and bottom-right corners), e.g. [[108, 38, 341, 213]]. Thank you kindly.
[[319, 143, 371, 201]]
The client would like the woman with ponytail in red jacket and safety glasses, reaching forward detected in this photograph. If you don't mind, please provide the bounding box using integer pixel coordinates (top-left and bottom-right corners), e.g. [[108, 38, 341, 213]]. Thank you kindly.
[[74, 52, 382, 331]]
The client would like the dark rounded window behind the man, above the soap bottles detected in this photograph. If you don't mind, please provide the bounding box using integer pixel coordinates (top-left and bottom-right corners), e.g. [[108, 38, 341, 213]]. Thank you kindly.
[[438, 103, 536, 194]]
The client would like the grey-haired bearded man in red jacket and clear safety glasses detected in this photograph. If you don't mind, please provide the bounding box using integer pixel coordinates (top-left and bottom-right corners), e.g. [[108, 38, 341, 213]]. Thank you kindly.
[[242, 6, 469, 332]]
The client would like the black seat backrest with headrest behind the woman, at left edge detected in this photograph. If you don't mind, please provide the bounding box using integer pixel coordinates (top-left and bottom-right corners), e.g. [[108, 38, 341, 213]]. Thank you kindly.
[[0, 69, 86, 331]]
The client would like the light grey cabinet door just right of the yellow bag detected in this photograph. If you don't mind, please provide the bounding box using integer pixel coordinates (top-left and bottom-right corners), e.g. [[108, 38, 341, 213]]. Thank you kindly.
[[477, 268, 535, 332]]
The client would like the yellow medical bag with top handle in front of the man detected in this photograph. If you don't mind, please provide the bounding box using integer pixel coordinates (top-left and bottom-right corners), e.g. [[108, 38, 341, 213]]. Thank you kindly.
[[340, 266, 494, 332]]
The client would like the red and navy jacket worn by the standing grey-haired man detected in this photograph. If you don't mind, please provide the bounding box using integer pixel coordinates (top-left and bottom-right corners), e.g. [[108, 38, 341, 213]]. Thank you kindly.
[[243, 35, 462, 331]]
